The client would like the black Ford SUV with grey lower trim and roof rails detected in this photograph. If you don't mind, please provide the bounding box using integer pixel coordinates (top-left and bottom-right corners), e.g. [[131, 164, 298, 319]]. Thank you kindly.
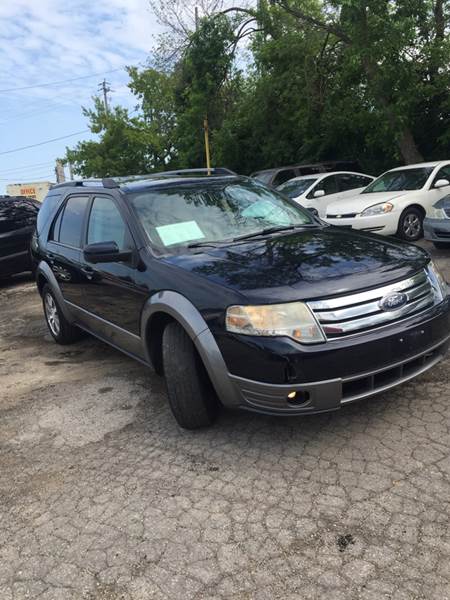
[[32, 170, 450, 429]]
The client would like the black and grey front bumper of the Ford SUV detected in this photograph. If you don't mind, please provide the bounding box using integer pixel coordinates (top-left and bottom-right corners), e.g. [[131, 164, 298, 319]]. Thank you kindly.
[[217, 297, 450, 416]]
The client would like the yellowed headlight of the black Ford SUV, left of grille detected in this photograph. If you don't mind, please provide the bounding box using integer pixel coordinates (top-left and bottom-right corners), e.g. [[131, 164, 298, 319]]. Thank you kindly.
[[226, 302, 325, 344]]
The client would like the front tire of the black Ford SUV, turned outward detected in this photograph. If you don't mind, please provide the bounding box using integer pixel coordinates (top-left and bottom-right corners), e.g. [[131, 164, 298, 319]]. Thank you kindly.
[[162, 322, 219, 429]]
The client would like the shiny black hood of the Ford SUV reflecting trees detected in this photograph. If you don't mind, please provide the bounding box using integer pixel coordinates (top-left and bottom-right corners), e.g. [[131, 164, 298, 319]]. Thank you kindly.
[[163, 227, 429, 303]]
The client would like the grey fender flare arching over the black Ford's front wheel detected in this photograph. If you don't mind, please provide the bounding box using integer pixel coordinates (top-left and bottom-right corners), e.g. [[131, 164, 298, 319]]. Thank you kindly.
[[141, 291, 240, 407]]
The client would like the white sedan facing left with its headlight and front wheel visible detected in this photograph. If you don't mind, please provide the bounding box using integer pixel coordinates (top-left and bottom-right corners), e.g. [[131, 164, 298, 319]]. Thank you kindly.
[[326, 161, 450, 242]]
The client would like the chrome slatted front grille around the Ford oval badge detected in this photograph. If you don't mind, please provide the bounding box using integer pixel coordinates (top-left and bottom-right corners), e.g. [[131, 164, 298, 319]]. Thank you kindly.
[[308, 271, 436, 339]]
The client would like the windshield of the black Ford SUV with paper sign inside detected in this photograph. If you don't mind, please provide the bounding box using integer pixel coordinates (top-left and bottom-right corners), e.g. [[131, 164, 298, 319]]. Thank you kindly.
[[130, 181, 319, 251]]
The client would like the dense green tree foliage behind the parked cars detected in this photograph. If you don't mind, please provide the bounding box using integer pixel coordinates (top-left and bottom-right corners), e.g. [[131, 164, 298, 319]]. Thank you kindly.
[[67, 0, 450, 176]]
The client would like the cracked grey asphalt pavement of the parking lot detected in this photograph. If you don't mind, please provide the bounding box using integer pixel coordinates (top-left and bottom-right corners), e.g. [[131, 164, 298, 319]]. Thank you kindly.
[[0, 244, 450, 600]]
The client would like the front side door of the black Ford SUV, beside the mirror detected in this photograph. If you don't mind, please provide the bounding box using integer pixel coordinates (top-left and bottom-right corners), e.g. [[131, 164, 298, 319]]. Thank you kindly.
[[79, 194, 148, 342]]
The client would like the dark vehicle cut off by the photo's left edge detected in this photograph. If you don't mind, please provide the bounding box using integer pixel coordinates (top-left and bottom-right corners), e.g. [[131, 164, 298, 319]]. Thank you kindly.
[[0, 196, 39, 278]]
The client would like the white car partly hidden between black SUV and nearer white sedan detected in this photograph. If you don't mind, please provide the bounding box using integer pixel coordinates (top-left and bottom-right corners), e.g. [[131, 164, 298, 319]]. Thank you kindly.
[[277, 171, 375, 218]]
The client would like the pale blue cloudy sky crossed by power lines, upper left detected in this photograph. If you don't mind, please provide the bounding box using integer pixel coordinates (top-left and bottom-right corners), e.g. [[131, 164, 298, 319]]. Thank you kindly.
[[0, 0, 160, 194]]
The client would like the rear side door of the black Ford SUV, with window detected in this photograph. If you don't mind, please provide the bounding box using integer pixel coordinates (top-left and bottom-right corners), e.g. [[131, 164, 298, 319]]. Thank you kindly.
[[45, 193, 89, 307]]
